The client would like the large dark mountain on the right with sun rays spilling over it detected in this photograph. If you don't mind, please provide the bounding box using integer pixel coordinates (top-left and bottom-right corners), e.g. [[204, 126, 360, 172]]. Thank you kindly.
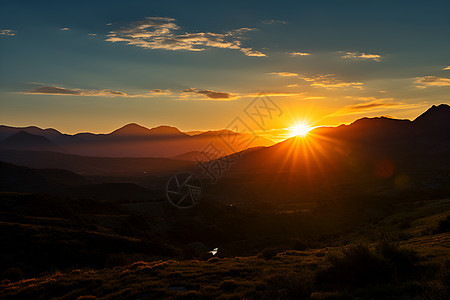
[[218, 105, 450, 205]]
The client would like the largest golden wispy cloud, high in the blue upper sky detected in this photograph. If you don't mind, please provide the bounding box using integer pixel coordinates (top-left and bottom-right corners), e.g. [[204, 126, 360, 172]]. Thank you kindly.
[[106, 17, 266, 57]]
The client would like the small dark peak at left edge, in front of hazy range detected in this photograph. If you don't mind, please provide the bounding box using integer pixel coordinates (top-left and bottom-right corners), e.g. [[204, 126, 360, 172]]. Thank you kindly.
[[0, 130, 65, 152]]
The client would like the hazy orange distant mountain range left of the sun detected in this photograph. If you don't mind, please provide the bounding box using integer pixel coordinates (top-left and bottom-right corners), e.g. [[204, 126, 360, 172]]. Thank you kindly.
[[0, 123, 273, 160]]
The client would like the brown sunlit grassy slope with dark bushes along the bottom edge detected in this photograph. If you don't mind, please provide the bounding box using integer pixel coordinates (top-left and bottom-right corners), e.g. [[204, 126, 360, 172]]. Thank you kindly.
[[0, 234, 448, 299]]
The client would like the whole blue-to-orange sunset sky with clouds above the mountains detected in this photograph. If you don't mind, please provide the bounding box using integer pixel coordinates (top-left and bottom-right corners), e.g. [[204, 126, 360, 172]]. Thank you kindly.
[[0, 0, 450, 140]]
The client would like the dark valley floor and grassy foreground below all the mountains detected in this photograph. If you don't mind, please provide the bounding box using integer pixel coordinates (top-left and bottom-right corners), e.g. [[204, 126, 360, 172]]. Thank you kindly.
[[0, 189, 450, 299]]
